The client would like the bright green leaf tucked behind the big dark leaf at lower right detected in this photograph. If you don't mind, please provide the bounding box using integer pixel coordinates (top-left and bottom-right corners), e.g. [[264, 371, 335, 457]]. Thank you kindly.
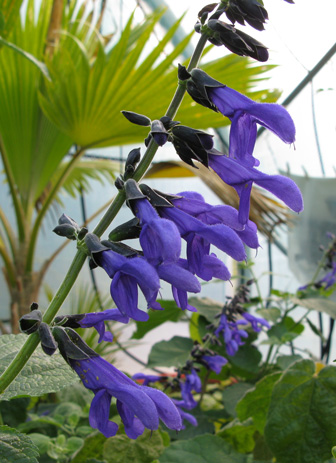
[[236, 373, 281, 434]]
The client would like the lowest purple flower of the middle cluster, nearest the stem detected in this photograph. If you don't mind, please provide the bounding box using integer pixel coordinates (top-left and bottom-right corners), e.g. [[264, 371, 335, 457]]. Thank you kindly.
[[94, 249, 160, 321]]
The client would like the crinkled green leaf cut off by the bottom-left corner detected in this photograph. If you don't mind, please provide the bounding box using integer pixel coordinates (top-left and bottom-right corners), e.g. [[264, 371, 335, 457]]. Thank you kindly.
[[0, 426, 39, 463]]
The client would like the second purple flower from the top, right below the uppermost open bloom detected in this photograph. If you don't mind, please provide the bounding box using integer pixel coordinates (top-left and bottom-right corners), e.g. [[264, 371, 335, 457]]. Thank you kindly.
[[209, 149, 303, 225]]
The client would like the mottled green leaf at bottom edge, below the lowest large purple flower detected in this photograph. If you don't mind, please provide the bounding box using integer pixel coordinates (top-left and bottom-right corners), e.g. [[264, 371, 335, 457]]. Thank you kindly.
[[104, 430, 165, 463]]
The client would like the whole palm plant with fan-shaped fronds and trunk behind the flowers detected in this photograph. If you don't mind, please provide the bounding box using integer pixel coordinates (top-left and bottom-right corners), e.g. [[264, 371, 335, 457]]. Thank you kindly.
[[0, 0, 278, 332]]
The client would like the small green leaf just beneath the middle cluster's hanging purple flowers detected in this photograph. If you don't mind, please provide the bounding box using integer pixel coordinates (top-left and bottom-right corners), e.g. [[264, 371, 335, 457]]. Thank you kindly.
[[132, 300, 183, 339]]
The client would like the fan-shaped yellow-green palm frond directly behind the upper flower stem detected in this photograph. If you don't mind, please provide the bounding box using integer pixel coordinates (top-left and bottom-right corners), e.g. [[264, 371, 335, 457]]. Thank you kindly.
[[39, 13, 277, 147]]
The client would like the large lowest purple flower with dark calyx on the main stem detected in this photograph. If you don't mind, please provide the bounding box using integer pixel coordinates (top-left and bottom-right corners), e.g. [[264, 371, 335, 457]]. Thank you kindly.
[[54, 327, 182, 439]]
